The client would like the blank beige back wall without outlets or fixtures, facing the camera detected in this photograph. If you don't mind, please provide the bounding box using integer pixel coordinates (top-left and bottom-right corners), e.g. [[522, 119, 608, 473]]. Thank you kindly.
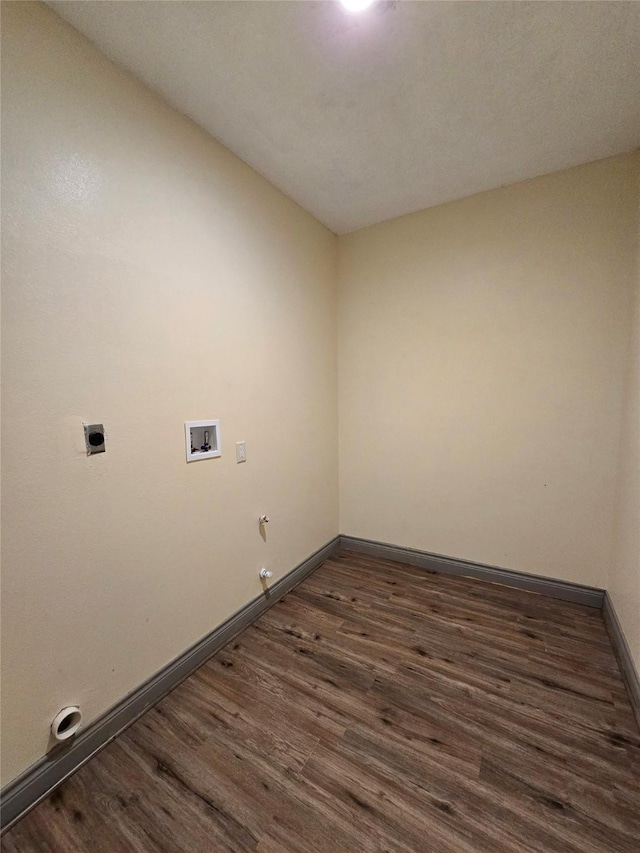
[[339, 154, 639, 587]]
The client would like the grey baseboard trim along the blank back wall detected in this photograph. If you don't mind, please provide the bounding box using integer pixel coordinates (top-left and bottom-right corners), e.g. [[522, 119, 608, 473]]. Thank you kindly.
[[340, 536, 605, 609]]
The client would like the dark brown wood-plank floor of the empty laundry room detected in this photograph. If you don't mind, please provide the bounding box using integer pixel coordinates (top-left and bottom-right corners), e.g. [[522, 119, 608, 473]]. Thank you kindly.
[[3, 552, 640, 853]]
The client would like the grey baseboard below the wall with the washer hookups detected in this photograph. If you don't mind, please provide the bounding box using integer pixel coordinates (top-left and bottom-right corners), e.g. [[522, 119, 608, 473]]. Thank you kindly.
[[1, 536, 340, 832]]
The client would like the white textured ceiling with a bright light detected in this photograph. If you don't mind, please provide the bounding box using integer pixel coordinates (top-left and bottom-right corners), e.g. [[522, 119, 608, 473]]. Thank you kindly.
[[49, 0, 640, 233]]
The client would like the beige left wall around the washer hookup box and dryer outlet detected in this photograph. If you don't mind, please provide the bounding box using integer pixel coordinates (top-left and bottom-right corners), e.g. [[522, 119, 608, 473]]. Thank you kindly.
[[2, 3, 338, 783]]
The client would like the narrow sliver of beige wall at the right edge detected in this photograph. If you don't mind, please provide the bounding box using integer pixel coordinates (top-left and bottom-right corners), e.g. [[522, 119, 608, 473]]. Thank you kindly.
[[609, 176, 640, 672]]
